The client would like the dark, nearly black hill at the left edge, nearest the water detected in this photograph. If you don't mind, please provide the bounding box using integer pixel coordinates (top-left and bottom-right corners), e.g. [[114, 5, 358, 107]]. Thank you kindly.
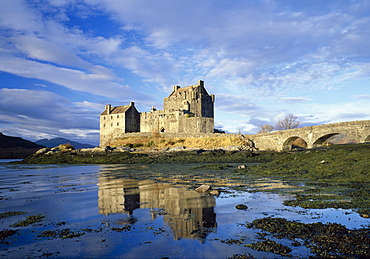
[[0, 132, 44, 159]]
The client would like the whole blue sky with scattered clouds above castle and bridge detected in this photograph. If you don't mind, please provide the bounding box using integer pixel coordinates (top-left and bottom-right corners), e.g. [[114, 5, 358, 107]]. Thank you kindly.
[[0, 0, 370, 145]]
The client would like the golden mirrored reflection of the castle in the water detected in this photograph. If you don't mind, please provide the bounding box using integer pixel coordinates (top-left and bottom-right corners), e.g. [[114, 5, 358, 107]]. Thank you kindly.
[[98, 175, 216, 241]]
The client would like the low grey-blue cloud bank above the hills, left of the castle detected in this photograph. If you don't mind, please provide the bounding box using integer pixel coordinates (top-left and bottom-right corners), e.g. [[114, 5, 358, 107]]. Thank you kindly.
[[0, 88, 100, 142]]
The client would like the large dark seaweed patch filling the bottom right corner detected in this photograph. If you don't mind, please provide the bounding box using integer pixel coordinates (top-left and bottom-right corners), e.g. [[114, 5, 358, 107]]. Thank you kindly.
[[247, 217, 370, 258]]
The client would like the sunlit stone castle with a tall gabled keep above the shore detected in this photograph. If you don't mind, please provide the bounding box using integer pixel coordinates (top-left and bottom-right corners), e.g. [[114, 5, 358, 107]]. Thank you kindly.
[[100, 80, 215, 146]]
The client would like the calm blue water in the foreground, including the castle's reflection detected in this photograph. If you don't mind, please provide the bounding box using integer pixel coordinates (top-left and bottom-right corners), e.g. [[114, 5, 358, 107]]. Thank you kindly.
[[0, 163, 369, 258]]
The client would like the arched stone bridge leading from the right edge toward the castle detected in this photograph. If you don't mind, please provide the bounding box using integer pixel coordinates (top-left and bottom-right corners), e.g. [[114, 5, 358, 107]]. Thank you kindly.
[[248, 120, 370, 151]]
